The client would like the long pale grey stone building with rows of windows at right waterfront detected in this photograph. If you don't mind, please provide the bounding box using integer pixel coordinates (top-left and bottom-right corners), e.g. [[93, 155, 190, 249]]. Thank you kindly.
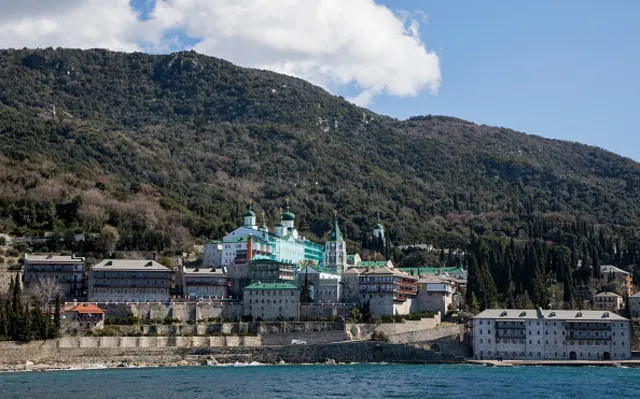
[[473, 309, 631, 360]]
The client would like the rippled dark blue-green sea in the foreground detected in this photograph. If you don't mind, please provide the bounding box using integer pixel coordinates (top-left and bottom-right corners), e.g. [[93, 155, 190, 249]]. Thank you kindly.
[[0, 364, 640, 399]]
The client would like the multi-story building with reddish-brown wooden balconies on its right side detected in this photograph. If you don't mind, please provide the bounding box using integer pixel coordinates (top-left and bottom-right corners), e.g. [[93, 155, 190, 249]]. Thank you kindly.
[[359, 267, 418, 316]]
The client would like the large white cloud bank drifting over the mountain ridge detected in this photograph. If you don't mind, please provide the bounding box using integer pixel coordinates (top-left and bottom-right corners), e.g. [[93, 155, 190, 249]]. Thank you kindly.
[[0, 0, 441, 105]]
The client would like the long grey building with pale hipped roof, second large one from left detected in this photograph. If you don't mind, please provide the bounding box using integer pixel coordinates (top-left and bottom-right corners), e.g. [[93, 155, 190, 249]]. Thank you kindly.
[[88, 259, 172, 302]]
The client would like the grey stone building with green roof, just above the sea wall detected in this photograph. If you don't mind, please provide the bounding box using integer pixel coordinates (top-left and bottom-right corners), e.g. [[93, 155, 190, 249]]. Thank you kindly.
[[243, 283, 300, 320]]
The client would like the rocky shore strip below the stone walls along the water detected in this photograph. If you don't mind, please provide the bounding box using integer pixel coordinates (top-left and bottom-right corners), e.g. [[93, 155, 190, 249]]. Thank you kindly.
[[0, 341, 464, 371]]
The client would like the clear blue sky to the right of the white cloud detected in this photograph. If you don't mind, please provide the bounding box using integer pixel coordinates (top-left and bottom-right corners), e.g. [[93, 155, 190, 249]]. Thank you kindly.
[[369, 0, 640, 160]]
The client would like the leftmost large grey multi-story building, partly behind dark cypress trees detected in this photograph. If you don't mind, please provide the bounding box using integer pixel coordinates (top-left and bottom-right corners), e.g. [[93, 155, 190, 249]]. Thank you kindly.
[[24, 254, 86, 299]]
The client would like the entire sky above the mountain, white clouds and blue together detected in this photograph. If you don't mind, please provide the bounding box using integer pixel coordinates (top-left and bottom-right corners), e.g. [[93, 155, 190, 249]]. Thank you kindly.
[[0, 0, 640, 160]]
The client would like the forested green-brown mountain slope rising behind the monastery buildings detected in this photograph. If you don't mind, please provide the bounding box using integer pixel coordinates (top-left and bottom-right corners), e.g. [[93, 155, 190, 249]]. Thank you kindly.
[[0, 49, 640, 250]]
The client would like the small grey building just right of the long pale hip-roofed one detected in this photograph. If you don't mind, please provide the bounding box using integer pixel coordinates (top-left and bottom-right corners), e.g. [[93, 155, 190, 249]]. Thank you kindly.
[[181, 267, 231, 299]]
